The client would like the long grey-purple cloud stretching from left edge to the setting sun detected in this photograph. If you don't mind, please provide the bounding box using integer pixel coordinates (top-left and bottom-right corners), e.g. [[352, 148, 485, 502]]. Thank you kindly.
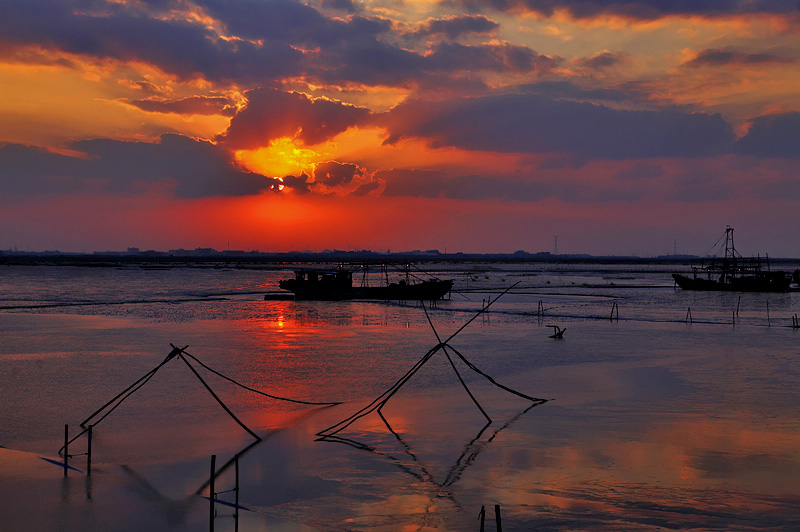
[[0, 134, 272, 198]]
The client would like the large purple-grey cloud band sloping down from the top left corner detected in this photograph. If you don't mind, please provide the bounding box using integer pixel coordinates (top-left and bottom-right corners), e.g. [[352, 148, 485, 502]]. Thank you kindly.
[[0, 0, 305, 82]]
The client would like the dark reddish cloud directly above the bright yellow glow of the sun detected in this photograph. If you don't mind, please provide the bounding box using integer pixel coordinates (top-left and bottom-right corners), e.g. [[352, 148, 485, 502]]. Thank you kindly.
[[220, 88, 370, 149]]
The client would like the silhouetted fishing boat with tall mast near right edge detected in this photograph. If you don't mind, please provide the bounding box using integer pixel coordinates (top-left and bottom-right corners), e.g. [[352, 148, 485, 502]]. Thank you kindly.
[[672, 226, 792, 292]]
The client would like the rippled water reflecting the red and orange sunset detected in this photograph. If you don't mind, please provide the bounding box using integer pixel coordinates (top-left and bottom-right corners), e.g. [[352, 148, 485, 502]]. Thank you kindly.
[[0, 263, 800, 531]]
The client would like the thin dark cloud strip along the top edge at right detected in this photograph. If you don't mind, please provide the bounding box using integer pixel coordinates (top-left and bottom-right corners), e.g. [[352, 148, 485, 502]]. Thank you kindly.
[[449, 0, 798, 20]]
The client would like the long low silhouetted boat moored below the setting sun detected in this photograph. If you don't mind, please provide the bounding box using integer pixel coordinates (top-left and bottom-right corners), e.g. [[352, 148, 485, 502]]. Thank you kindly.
[[279, 268, 453, 301]]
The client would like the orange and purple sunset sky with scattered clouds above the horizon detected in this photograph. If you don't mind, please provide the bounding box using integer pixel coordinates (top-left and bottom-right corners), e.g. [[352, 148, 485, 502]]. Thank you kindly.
[[0, 0, 800, 257]]
